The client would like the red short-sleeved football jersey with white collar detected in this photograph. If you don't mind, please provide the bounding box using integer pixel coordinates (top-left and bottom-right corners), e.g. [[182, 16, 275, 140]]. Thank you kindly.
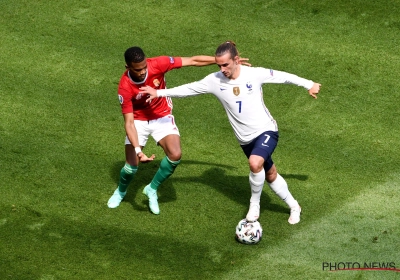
[[118, 56, 182, 121]]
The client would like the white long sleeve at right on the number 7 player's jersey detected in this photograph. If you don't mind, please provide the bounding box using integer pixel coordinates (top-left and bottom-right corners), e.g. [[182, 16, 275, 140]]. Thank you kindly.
[[257, 67, 314, 90]]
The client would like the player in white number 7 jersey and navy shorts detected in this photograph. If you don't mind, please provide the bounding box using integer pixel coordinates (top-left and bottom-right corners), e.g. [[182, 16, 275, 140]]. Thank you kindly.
[[141, 41, 321, 224]]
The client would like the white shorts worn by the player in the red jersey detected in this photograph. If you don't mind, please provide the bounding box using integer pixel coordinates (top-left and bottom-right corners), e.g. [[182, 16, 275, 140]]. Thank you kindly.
[[125, 115, 179, 147]]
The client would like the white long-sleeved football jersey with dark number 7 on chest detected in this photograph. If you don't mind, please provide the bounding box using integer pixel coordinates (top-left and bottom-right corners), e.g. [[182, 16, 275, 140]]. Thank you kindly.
[[157, 65, 314, 145]]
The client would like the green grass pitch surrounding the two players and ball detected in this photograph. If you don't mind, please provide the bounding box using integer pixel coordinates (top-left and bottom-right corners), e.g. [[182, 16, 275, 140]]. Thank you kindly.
[[0, 0, 400, 280]]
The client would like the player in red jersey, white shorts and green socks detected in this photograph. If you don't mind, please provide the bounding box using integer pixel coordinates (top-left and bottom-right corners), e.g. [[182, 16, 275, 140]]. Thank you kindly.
[[107, 47, 247, 214]]
